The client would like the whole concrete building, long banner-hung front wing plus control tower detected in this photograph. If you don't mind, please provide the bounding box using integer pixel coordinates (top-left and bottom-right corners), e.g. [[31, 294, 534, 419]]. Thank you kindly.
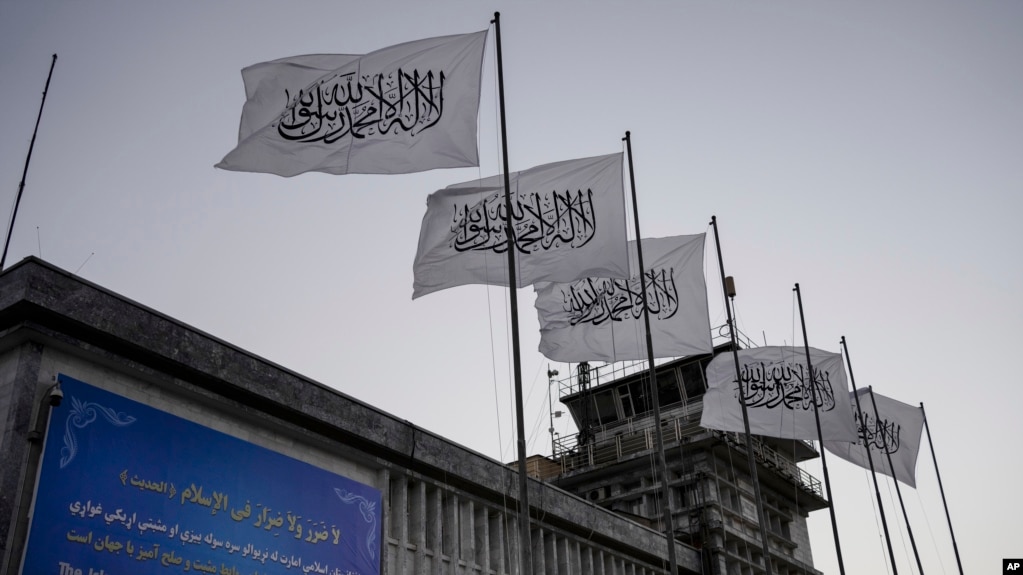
[[0, 258, 827, 575]]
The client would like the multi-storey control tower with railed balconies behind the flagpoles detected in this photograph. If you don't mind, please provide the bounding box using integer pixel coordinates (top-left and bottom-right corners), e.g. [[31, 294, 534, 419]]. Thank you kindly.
[[532, 356, 828, 575]]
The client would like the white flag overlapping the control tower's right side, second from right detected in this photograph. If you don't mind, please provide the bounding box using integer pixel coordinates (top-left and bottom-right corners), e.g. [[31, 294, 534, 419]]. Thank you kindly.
[[700, 347, 856, 441]]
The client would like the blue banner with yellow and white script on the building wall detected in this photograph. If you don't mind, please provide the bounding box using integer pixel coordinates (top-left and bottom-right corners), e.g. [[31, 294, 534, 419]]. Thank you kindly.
[[23, 375, 381, 575]]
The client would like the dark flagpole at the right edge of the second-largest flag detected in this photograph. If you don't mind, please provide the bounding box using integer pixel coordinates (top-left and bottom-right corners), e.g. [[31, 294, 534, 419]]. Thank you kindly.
[[622, 132, 678, 575]]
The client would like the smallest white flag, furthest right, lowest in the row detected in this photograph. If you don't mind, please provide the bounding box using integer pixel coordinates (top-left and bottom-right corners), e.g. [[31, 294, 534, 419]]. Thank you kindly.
[[825, 389, 924, 488]]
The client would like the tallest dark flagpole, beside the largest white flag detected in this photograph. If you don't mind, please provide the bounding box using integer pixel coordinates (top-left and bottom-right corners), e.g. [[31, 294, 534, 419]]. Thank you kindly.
[[490, 12, 533, 575]]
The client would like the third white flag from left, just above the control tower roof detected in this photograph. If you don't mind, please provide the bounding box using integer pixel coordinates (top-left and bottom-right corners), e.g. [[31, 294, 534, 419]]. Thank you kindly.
[[535, 233, 714, 362]]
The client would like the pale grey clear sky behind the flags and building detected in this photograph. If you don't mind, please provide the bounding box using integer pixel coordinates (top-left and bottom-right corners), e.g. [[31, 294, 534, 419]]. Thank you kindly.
[[0, 0, 1023, 574]]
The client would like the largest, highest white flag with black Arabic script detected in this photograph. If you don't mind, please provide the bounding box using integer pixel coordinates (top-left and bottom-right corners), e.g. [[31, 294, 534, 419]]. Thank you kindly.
[[217, 31, 487, 176]]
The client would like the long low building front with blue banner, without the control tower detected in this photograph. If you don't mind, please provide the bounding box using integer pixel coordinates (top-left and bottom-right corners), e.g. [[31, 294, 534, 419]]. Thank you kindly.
[[0, 258, 703, 575]]
